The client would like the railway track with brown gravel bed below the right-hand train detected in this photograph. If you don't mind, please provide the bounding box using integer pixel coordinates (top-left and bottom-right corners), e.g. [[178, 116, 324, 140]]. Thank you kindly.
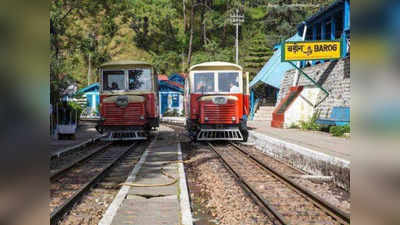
[[208, 143, 350, 225]]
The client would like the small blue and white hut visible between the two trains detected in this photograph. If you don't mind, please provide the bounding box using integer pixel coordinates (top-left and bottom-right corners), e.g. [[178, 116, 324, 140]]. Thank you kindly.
[[158, 74, 185, 117]]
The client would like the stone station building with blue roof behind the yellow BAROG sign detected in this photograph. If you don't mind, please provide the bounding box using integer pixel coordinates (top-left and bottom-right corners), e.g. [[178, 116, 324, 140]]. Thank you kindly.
[[249, 0, 350, 128]]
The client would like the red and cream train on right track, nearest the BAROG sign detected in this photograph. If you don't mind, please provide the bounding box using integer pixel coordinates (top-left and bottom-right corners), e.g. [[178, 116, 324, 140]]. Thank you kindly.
[[185, 62, 250, 141]]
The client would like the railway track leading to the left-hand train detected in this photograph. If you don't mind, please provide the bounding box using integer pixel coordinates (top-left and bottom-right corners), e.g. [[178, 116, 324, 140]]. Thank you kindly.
[[50, 143, 138, 224]]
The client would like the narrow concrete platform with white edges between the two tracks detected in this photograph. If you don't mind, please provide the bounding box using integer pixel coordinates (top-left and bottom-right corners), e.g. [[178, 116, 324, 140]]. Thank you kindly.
[[99, 125, 192, 225]]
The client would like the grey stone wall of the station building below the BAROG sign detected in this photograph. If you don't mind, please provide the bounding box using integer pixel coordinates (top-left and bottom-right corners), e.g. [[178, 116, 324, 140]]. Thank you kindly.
[[277, 57, 351, 118]]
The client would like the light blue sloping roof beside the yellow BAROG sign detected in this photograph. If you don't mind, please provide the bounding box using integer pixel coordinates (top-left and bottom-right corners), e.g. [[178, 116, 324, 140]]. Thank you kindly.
[[250, 34, 302, 88]]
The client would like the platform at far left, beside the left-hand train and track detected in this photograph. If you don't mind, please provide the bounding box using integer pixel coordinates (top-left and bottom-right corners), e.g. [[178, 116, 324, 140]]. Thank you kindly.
[[49, 121, 101, 155]]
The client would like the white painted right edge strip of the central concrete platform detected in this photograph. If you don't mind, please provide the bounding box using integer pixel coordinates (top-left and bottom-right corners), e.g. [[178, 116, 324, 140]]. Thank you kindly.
[[178, 142, 193, 225]]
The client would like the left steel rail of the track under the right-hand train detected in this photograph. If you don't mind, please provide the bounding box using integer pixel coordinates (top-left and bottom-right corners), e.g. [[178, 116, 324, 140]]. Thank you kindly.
[[207, 143, 290, 225]]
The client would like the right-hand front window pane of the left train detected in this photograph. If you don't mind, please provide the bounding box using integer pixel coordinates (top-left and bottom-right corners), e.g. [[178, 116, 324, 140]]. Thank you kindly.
[[128, 69, 151, 91]]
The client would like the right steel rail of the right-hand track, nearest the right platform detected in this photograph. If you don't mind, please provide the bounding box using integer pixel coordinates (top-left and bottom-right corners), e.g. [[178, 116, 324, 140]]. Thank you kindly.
[[231, 143, 350, 224]]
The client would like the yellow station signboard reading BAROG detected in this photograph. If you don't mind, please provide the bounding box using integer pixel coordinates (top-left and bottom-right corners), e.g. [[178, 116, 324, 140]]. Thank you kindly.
[[281, 40, 342, 62]]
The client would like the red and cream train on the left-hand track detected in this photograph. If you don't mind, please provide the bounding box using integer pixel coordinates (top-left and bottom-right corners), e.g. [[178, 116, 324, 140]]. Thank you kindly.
[[96, 60, 159, 141]]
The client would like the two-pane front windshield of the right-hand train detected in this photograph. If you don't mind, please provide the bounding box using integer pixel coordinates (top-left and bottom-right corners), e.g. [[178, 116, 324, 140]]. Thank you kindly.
[[193, 71, 242, 94]]
